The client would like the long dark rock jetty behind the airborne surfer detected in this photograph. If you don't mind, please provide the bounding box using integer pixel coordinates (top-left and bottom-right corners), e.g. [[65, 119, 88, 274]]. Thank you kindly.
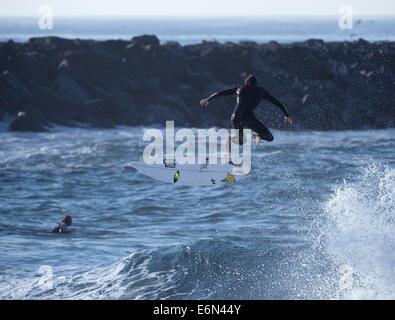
[[0, 35, 395, 130]]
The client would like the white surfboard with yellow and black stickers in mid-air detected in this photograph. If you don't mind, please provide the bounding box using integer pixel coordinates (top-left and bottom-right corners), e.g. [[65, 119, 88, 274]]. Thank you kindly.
[[131, 159, 247, 186]]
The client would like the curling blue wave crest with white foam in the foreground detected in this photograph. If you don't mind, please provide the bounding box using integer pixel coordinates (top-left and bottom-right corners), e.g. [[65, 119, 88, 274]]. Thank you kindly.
[[0, 237, 356, 299]]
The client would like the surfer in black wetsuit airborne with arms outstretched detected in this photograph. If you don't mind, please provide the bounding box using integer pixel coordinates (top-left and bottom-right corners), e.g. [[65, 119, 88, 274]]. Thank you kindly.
[[200, 75, 292, 150]]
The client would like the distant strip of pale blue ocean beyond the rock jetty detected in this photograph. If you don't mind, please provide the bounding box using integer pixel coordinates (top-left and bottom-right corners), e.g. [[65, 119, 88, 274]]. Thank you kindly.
[[0, 15, 395, 45]]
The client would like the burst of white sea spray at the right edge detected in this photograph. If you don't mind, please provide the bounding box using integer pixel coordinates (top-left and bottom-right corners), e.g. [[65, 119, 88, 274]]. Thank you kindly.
[[325, 165, 395, 299]]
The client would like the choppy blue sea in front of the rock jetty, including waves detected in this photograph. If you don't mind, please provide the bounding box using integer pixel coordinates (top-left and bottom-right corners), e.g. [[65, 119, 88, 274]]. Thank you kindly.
[[0, 123, 395, 299]]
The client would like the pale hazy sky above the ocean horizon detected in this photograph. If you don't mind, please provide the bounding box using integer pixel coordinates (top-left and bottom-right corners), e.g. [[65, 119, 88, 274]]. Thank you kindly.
[[0, 0, 395, 16]]
